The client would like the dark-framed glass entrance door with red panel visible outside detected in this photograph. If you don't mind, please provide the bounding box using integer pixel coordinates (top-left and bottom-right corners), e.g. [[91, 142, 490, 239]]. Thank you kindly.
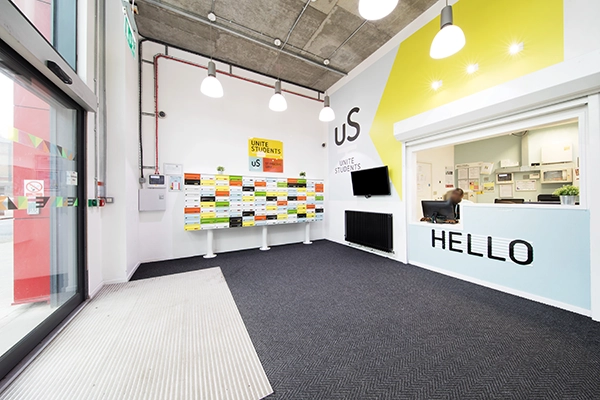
[[0, 42, 84, 379]]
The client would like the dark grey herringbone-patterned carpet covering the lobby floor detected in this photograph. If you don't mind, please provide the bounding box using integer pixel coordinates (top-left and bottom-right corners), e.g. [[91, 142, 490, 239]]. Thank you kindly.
[[132, 241, 600, 399]]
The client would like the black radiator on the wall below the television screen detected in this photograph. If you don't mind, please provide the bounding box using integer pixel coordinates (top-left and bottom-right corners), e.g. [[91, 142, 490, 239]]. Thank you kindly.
[[345, 210, 394, 253]]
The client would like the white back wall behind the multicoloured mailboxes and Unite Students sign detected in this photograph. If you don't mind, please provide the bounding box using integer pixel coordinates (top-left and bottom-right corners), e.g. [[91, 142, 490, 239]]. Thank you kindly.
[[136, 42, 329, 262]]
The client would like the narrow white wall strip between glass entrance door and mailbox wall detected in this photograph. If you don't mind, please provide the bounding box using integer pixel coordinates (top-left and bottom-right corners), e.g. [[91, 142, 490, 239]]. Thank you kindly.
[[101, 1, 139, 283]]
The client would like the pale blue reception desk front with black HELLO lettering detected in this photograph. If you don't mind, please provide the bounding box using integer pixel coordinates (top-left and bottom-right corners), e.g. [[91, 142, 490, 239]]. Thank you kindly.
[[408, 204, 591, 315]]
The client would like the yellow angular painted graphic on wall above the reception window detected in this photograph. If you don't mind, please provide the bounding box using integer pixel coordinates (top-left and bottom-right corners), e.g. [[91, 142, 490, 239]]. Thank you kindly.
[[369, 0, 564, 198]]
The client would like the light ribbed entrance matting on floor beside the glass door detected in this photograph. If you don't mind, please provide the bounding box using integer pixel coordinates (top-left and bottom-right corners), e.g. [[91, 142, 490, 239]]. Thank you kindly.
[[0, 268, 273, 400]]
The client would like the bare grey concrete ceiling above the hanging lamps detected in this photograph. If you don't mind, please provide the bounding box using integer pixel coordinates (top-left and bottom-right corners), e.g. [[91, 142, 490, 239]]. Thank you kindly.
[[136, 0, 437, 92]]
